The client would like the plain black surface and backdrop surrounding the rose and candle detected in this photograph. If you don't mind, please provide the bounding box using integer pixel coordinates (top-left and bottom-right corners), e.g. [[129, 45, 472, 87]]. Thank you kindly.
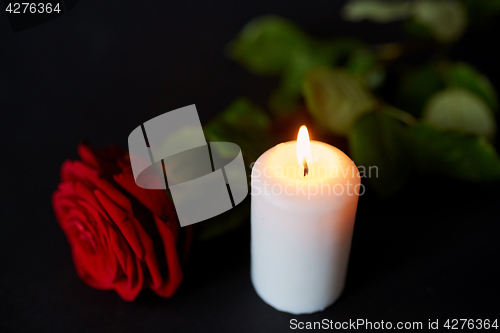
[[0, 0, 500, 332]]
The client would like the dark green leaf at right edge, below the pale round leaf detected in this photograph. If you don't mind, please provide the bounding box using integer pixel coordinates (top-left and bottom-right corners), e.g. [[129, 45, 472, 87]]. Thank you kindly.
[[411, 122, 500, 181]]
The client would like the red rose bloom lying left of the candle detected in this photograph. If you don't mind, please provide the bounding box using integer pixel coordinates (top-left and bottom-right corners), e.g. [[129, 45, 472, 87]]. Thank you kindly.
[[52, 144, 191, 301]]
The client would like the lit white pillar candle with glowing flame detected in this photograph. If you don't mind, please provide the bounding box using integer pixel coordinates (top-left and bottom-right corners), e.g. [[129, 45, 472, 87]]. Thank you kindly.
[[251, 126, 363, 314]]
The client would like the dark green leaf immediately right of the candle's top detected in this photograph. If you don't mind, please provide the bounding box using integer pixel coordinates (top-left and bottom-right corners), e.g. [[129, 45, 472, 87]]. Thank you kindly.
[[349, 109, 411, 195]]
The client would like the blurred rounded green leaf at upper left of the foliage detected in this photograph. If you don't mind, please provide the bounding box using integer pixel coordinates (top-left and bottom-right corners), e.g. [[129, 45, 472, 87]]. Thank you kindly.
[[228, 16, 309, 75]]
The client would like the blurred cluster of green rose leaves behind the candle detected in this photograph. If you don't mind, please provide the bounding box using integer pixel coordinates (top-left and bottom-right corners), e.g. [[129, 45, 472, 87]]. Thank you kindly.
[[198, 0, 500, 239]]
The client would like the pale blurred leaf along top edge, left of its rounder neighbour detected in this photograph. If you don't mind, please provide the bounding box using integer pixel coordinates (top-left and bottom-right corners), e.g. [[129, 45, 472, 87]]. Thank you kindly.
[[342, 0, 411, 23]]
